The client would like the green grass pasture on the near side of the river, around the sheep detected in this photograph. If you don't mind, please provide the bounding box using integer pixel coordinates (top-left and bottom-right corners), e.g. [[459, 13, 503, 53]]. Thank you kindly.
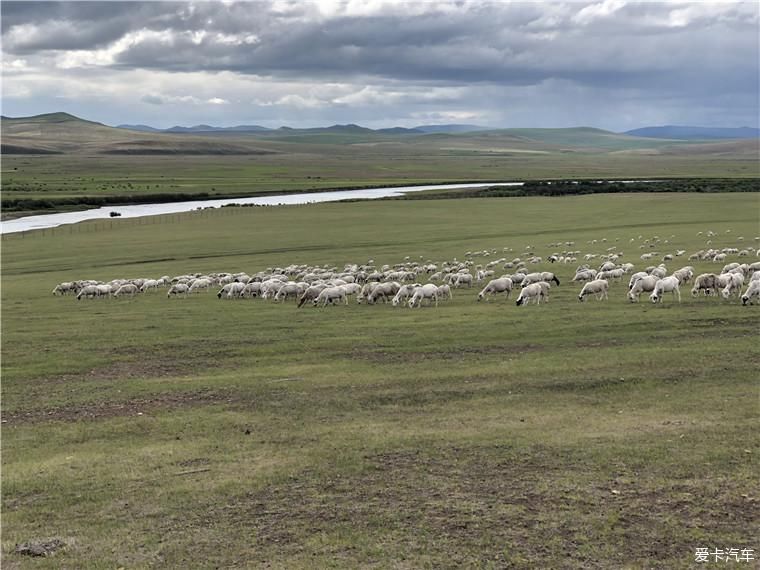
[[2, 193, 760, 569]]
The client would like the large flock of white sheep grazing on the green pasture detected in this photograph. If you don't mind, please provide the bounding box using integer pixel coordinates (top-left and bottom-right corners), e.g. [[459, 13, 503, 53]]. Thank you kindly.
[[53, 232, 760, 308]]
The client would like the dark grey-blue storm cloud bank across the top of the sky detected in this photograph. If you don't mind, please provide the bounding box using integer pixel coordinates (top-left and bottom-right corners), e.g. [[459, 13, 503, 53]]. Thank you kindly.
[[3, 2, 757, 86]]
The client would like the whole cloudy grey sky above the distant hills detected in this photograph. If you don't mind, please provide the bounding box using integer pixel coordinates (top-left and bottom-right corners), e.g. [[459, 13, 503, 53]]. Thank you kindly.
[[0, 0, 760, 131]]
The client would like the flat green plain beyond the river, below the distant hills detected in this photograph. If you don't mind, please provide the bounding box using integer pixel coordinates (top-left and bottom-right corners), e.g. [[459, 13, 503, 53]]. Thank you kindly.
[[2, 146, 759, 200]]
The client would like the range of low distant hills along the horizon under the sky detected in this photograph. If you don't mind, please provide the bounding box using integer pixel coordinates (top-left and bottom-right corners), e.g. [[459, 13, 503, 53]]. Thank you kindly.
[[0, 112, 760, 158]]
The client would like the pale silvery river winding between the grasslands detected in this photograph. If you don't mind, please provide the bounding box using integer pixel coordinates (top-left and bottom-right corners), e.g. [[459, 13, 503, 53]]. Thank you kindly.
[[0, 182, 523, 234]]
